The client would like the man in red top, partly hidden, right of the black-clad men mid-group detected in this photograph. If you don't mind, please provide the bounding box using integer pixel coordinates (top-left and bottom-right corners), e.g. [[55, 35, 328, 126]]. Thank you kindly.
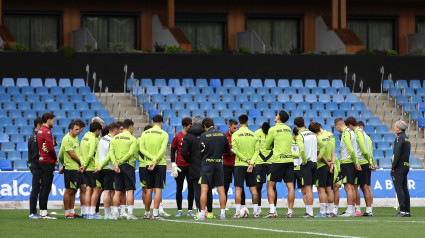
[[223, 119, 245, 206]]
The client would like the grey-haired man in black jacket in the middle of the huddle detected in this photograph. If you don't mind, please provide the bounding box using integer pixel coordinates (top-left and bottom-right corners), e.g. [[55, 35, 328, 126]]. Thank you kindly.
[[181, 115, 213, 215]]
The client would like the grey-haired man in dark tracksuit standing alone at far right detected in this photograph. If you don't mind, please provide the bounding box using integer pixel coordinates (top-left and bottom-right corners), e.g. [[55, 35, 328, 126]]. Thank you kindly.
[[391, 121, 410, 217]]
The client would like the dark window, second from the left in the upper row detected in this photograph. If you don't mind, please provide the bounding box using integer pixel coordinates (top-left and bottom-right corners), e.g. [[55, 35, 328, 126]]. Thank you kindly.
[[81, 14, 137, 49]]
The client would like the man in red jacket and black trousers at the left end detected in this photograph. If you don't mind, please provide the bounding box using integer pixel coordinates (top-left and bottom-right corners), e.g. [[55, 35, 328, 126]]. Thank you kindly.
[[37, 112, 59, 219]]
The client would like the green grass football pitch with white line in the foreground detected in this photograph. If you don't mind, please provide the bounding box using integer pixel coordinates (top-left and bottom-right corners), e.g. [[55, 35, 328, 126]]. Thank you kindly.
[[0, 207, 425, 238]]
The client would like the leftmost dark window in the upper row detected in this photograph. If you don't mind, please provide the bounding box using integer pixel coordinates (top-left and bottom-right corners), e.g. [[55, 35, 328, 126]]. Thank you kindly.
[[3, 13, 60, 50]]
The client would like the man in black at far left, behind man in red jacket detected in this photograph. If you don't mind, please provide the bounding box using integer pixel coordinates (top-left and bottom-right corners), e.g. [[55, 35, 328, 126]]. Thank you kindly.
[[28, 117, 43, 219]]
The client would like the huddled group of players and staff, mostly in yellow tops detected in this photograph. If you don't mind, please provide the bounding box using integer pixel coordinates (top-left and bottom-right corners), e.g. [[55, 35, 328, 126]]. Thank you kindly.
[[30, 110, 376, 220]]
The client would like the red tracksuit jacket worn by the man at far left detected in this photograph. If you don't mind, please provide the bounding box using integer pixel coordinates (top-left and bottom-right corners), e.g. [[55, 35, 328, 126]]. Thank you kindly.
[[37, 125, 58, 163]]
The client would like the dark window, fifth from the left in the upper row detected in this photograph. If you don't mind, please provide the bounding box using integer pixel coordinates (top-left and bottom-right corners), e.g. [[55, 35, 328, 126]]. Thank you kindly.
[[347, 17, 396, 51]]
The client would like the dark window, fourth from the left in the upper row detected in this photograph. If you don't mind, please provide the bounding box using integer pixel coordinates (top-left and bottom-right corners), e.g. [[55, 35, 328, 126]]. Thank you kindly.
[[246, 14, 302, 53]]
